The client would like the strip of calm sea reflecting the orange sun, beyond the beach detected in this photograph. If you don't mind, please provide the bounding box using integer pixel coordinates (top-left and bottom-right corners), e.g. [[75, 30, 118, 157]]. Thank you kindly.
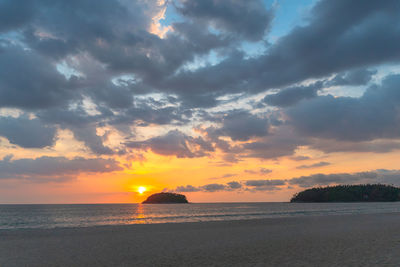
[[0, 202, 400, 229]]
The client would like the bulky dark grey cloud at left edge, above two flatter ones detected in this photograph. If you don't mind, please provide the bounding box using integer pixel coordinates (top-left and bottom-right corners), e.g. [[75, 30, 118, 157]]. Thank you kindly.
[[0, 44, 74, 109]]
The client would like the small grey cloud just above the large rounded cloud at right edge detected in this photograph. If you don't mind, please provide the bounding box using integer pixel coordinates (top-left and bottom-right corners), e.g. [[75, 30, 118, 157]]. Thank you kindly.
[[326, 69, 376, 86]]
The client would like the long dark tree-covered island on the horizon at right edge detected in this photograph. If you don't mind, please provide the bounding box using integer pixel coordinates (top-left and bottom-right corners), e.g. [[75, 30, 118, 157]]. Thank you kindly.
[[290, 184, 400, 202]]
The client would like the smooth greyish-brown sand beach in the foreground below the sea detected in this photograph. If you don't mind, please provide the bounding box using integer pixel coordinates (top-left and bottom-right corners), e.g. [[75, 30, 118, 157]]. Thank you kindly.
[[0, 213, 400, 266]]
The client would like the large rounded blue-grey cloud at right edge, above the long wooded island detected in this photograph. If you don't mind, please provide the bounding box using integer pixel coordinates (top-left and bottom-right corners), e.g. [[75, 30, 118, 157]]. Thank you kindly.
[[286, 75, 400, 141]]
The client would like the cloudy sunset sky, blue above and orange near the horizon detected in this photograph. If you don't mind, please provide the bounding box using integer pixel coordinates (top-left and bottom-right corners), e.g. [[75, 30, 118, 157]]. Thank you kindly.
[[0, 0, 400, 203]]
